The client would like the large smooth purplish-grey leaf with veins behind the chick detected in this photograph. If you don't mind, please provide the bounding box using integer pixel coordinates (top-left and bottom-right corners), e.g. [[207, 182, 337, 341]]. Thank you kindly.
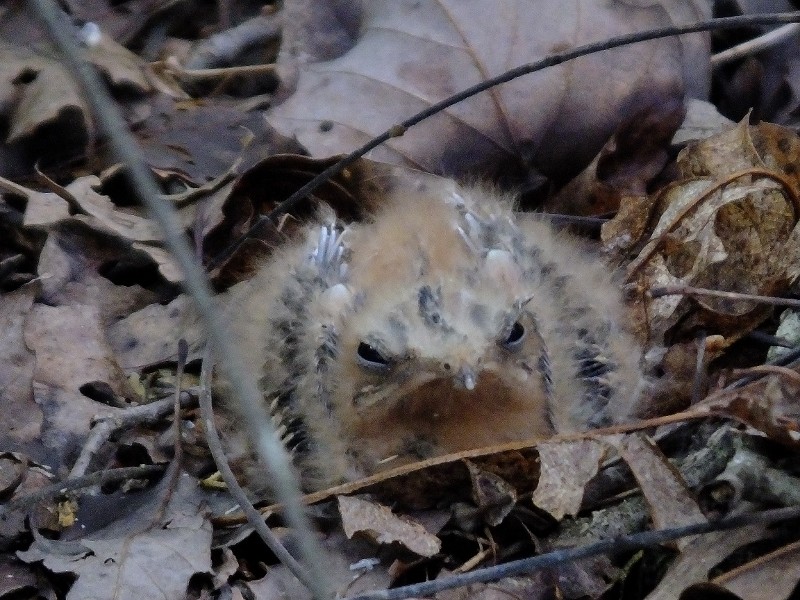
[[268, 0, 710, 176]]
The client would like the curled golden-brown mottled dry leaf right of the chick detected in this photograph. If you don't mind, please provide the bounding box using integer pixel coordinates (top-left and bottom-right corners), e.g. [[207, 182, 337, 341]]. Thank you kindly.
[[603, 122, 800, 343]]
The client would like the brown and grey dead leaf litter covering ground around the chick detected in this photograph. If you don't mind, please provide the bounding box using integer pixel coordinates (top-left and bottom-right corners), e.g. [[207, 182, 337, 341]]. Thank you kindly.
[[0, 2, 800, 598]]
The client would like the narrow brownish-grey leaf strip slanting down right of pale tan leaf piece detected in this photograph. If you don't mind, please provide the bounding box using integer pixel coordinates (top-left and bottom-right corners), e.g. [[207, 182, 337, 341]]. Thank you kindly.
[[617, 434, 706, 548]]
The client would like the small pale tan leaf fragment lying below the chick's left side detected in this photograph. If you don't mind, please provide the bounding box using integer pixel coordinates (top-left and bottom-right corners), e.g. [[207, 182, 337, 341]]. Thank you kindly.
[[337, 496, 442, 557]]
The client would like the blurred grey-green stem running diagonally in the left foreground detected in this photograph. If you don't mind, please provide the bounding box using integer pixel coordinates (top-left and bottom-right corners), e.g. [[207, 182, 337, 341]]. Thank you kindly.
[[29, 0, 330, 600]]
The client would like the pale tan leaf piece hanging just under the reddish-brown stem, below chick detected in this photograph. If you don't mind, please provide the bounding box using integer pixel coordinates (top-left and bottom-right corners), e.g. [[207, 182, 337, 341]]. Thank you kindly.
[[533, 440, 606, 521]]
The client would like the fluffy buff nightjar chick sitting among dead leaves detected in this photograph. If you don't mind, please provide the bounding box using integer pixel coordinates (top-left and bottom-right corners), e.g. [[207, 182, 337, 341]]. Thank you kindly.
[[220, 182, 641, 488]]
